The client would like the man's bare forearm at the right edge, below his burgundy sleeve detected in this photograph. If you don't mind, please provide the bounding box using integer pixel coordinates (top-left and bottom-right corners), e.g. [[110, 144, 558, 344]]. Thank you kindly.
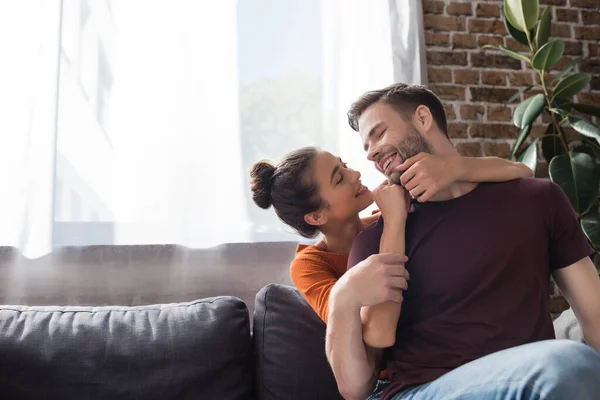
[[553, 257, 600, 353]]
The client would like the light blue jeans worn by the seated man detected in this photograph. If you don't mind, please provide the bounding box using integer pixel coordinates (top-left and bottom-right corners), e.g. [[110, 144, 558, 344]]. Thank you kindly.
[[368, 340, 600, 400]]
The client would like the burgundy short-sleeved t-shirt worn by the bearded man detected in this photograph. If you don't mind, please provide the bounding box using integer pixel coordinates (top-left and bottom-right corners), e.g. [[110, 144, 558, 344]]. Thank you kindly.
[[348, 179, 593, 399]]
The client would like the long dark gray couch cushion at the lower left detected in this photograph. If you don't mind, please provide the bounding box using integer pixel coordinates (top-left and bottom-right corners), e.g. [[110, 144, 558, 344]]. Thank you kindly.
[[0, 297, 253, 400]]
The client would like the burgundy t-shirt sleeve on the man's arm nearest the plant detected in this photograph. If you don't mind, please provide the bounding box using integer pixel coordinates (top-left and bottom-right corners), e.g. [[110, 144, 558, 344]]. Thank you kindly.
[[548, 182, 594, 271]]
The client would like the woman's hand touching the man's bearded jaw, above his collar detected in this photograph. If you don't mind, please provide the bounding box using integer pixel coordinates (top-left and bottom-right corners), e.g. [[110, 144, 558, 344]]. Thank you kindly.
[[396, 153, 463, 202]]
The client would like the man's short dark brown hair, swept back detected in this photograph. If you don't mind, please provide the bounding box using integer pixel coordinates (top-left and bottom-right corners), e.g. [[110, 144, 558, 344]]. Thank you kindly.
[[348, 83, 448, 136]]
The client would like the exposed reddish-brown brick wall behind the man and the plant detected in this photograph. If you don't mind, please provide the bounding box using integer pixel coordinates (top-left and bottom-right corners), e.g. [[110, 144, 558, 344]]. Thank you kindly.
[[423, 0, 600, 176]]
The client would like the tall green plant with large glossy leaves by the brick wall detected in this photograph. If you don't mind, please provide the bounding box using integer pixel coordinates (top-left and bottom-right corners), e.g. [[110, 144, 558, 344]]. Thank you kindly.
[[483, 0, 600, 271]]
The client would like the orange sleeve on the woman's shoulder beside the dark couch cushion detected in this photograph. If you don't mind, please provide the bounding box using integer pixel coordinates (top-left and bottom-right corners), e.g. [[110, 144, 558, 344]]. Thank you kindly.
[[290, 256, 338, 323]]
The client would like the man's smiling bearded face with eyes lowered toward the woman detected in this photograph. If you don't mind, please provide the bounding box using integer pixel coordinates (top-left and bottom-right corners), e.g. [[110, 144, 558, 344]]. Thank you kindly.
[[358, 102, 430, 177]]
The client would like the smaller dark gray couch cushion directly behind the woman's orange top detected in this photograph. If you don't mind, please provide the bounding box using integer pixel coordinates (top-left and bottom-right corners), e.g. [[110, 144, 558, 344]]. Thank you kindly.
[[252, 284, 341, 400]]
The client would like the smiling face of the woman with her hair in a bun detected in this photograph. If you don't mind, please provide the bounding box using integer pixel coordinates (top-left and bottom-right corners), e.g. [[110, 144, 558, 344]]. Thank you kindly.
[[313, 151, 374, 222]]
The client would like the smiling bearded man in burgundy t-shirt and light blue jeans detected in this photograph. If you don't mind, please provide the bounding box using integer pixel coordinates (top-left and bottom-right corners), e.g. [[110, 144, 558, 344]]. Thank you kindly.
[[326, 84, 600, 400]]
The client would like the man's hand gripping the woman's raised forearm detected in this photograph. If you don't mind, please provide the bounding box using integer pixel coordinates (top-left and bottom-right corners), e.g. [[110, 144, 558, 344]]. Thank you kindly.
[[332, 253, 410, 309]]
